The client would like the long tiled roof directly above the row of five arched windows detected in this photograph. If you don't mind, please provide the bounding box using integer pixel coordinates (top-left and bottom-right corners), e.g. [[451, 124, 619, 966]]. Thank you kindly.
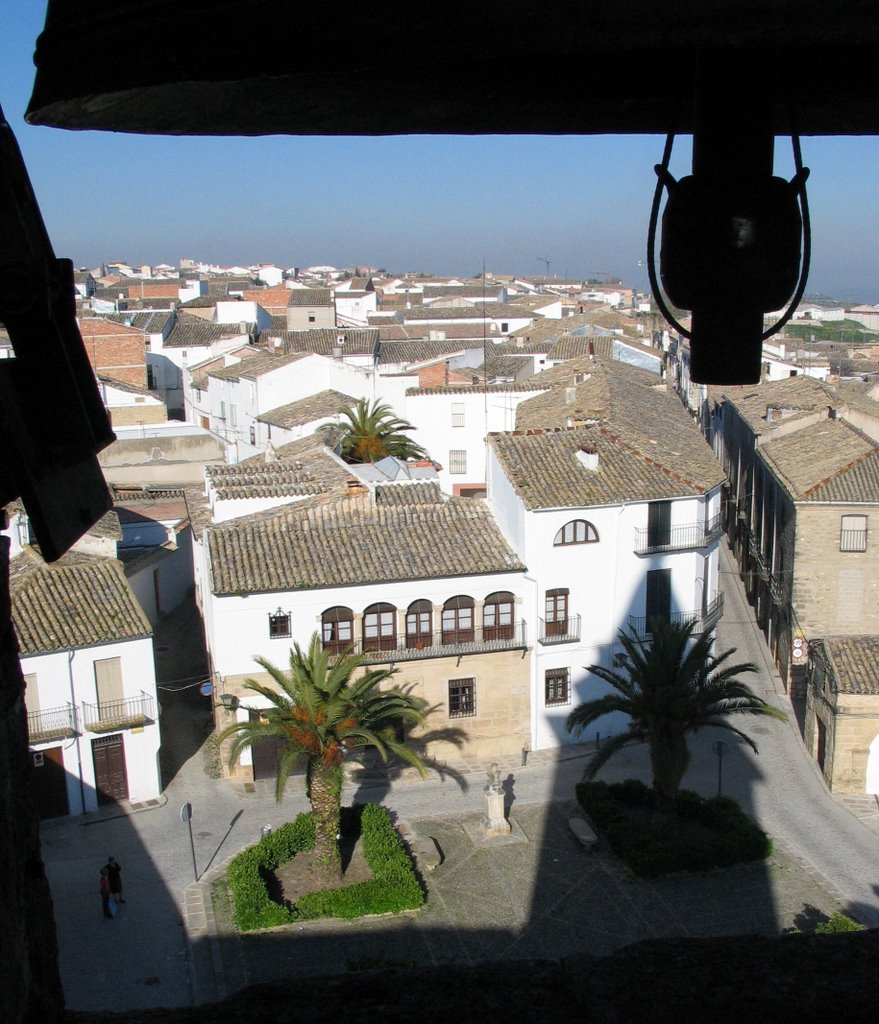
[[208, 485, 525, 594]]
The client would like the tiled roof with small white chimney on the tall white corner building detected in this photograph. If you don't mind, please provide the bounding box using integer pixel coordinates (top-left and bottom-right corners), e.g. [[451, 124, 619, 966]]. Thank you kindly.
[[489, 424, 723, 509]]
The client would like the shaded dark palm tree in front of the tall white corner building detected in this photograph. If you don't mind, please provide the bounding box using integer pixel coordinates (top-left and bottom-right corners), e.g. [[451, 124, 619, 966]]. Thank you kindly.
[[567, 618, 787, 820]]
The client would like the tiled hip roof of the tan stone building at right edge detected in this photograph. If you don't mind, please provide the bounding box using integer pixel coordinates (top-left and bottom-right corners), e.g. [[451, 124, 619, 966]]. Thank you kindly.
[[758, 419, 879, 504]]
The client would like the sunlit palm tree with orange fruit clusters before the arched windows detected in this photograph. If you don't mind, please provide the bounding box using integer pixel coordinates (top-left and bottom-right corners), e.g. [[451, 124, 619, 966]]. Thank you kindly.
[[219, 633, 434, 879]]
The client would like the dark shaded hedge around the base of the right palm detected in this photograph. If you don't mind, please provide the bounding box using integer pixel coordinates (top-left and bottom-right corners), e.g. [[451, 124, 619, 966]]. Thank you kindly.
[[577, 779, 772, 879]]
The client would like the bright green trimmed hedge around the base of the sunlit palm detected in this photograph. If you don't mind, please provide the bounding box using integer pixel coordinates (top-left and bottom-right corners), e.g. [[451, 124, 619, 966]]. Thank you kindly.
[[226, 804, 424, 932]]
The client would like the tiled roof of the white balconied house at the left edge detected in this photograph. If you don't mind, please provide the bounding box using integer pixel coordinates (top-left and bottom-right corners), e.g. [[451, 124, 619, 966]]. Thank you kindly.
[[10, 548, 153, 654]]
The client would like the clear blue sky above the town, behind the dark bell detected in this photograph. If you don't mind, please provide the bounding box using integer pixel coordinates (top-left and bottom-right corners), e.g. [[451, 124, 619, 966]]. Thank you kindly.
[[0, 8, 879, 302]]
